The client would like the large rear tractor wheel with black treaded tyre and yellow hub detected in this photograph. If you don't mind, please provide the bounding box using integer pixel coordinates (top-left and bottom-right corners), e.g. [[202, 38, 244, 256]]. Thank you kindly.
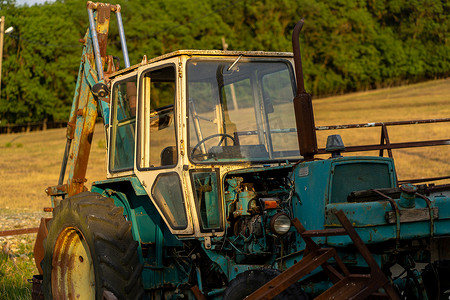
[[41, 192, 144, 299]]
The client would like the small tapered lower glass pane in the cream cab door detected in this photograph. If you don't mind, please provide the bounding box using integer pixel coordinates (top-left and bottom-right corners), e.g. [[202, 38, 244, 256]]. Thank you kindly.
[[152, 173, 187, 229]]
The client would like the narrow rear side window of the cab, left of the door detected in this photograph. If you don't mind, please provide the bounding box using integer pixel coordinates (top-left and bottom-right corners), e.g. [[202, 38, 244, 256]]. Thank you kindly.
[[110, 76, 137, 171]]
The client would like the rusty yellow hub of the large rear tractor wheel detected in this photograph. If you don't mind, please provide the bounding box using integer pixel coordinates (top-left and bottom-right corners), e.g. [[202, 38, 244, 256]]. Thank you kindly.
[[51, 227, 95, 299]]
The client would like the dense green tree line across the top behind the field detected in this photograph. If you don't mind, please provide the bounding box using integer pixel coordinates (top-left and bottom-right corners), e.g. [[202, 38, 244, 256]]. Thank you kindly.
[[0, 0, 450, 125]]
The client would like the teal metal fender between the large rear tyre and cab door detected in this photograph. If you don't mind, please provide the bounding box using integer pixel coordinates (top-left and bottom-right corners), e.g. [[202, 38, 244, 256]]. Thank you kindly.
[[92, 176, 192, 289]]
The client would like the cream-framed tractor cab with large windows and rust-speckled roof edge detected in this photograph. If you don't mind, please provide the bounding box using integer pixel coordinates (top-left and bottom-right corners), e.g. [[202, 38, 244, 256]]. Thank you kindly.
[[108, 50, 301, 236]]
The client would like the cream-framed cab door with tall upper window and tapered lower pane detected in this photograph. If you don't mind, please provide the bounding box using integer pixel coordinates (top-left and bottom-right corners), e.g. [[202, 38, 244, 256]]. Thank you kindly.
[[135, 57, 193, 235]]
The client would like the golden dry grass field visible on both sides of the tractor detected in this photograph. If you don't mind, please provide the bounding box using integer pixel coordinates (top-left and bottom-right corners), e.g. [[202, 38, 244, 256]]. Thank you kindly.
[[0, 79, 450, 211]]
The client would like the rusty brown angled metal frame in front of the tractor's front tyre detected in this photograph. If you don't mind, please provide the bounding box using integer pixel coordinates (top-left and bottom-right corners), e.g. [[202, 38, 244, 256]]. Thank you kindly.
[[246, 211, 400, 300]]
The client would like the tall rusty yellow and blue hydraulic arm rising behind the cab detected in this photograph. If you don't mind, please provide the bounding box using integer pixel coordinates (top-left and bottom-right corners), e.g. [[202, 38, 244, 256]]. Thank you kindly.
[[34, 1, 130, 274]]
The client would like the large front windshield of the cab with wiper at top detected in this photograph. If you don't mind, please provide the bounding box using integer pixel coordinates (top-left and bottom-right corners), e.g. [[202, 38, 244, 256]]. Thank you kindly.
[[187, 57, 300, 163]]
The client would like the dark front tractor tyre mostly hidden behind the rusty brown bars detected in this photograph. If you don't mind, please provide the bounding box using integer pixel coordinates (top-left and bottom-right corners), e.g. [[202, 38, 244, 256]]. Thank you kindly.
[[223, 269, 309, 300]]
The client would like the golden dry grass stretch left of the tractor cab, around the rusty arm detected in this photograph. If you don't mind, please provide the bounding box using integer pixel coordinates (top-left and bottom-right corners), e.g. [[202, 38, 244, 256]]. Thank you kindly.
[[0, 125, 106, 211]]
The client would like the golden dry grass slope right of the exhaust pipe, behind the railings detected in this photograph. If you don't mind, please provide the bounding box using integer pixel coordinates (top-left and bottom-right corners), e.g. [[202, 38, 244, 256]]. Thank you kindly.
[[313, 79, 450, 183]]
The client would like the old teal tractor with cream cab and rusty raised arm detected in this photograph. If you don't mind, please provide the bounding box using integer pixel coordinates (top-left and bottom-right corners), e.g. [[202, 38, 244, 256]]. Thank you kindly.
[[35, 2, 450, 300]]
